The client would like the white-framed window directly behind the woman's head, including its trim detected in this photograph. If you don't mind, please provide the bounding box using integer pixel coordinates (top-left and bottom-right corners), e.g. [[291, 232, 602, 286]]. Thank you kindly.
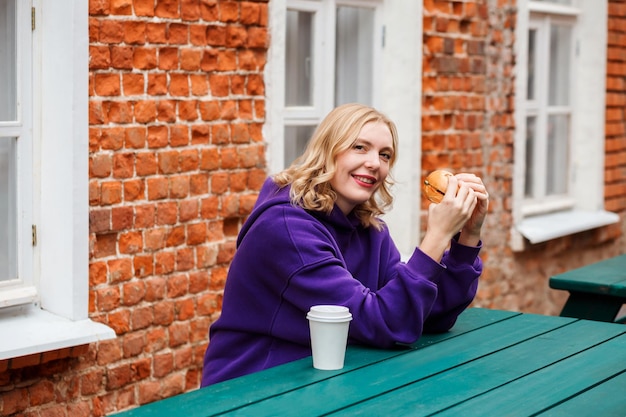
[[265, 0, 422, 254]]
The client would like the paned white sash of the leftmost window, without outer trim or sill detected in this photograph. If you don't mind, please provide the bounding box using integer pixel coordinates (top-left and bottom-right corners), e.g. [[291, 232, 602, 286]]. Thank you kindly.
[[0, 0, 36, 307]]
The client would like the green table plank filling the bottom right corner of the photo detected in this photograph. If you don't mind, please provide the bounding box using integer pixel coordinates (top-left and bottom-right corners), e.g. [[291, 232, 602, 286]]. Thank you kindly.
[[537, 371, 626, 417]]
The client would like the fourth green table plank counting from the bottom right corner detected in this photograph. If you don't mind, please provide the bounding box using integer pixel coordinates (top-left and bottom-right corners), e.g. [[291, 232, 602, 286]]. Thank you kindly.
[[219, 315, 576, 417]]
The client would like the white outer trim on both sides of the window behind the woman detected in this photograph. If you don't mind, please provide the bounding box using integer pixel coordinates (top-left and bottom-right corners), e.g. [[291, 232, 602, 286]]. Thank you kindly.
[[264, 0, 422, 255]]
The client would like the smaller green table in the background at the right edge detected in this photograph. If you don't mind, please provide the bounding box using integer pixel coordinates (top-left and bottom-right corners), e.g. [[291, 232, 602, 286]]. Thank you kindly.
[[549, 255, 626, 322]]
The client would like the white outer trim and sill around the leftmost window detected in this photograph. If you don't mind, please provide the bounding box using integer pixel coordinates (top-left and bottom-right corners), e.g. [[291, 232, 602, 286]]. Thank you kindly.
[[0, 0, 115, 360]]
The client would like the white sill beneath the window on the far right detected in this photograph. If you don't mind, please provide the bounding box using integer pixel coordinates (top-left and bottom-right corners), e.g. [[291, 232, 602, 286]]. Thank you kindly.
[[515, 210, 620, 243]]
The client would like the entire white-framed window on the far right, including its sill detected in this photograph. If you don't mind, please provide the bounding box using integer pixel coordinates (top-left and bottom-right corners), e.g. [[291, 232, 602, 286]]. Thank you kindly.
[[512, 0, 618, 250]]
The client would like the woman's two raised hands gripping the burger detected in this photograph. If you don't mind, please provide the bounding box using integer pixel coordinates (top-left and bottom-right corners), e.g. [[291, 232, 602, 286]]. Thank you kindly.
[[420, 173, 489, 261]]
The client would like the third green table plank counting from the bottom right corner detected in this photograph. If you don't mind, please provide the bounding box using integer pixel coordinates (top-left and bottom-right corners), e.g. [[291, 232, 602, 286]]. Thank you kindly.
[[324, 316, 621, 416]]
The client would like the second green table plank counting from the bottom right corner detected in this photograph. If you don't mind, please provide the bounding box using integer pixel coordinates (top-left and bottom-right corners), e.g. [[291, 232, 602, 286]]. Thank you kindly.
[[437, 330, 626, 417]]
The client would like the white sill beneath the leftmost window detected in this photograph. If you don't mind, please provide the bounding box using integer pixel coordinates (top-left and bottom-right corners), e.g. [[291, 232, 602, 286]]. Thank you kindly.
[[0, 305, 115, 360]]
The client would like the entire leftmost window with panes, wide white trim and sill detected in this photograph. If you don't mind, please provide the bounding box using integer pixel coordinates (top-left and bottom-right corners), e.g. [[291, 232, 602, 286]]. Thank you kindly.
[[0, 0, 115, 360]]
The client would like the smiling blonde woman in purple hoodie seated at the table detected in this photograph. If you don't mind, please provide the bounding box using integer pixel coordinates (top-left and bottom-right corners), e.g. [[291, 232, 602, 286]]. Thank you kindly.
[[202, 104, 489, 386]]
